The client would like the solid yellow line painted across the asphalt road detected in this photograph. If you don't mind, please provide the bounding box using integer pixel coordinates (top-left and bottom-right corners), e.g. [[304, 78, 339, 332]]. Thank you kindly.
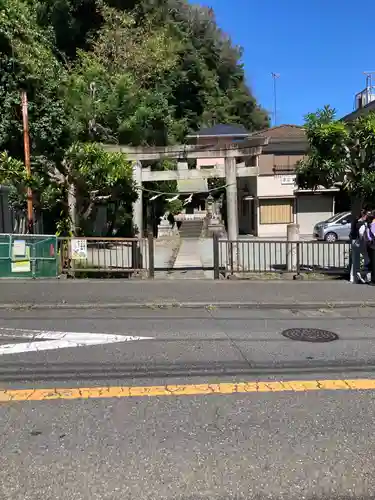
[[0, 379, 375, 403]]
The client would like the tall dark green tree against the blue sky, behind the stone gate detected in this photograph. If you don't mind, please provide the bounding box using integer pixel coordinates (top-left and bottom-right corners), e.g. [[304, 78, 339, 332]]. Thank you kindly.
[[157, 0, 269, 131]]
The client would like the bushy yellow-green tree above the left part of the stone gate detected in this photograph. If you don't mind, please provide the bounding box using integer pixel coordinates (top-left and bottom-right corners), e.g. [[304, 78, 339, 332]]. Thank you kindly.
[[65, 8, 182, 145]]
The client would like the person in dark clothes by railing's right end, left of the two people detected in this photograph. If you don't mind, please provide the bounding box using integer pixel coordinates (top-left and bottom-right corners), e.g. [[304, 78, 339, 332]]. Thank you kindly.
[[349, 209, 368, 283]]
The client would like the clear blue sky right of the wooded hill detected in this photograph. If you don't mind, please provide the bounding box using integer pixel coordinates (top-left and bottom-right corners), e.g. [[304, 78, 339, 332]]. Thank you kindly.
[[204, 0, 375, 124]]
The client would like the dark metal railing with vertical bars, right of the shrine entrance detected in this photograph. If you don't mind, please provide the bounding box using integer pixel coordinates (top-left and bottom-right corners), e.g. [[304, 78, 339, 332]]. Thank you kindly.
[[213, 238, 350, 279]]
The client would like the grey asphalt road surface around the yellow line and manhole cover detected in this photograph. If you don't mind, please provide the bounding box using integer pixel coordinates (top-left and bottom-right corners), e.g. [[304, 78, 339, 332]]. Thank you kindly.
[[0, 308, 375, 500]]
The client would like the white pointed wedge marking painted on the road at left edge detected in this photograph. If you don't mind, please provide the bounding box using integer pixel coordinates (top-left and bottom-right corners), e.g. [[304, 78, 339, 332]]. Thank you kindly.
[[0, 328, 154, 356]]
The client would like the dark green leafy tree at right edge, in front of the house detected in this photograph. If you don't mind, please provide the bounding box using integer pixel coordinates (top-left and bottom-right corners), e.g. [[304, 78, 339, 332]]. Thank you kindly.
[[297, 106, 375, 211]]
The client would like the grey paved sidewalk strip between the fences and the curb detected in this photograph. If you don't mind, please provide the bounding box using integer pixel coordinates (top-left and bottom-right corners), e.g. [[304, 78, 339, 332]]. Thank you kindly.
[[0, 280, 375, 309]]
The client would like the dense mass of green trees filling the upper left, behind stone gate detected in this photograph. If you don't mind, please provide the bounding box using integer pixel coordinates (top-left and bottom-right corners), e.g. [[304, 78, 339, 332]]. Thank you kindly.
[[0, 0, 268, 234]]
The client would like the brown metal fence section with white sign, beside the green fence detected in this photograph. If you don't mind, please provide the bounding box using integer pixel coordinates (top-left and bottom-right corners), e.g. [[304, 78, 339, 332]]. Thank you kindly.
[[59, 237, 154, 278]]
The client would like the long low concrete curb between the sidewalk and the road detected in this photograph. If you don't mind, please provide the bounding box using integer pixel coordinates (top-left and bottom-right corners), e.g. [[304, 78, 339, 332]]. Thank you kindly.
[[0, 300, 375, 310]]
